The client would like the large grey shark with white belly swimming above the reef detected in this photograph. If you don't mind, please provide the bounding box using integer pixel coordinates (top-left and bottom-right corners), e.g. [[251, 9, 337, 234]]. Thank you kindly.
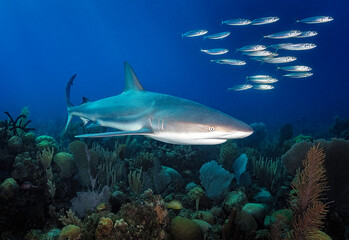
[[65, 62, 253, 145]]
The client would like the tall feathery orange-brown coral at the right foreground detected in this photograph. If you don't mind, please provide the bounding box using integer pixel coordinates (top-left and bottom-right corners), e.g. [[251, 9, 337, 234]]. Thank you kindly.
[[290, 146, 328, 240]]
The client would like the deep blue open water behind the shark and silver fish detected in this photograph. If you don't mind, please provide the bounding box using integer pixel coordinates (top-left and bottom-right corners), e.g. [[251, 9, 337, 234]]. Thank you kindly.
[[0, 0, 349, 133]]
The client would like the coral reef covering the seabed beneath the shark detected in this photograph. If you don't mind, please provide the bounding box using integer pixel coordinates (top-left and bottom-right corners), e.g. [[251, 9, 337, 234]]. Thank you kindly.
[[0, 109, 349, 240]]
